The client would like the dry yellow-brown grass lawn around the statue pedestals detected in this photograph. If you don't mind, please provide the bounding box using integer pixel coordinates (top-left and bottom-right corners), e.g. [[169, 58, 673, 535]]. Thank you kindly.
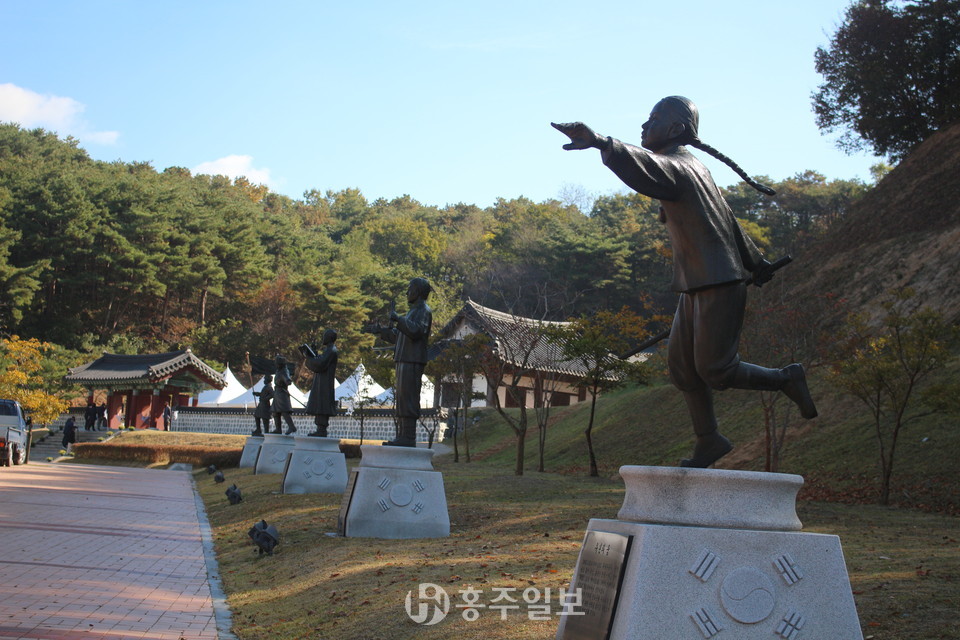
[[196, 456, 960, 640]]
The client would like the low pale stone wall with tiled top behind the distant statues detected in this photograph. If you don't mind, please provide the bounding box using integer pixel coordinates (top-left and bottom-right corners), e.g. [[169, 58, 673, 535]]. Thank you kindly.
[[170, 407, 447, 442]]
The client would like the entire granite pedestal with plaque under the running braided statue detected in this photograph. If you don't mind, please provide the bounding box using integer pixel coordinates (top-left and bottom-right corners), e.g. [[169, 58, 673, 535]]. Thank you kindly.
[[556, 466, 863, 640]]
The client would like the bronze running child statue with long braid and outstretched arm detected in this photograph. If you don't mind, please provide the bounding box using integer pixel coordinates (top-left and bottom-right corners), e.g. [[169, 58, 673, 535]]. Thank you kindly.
[[552, 96, 817, 468]]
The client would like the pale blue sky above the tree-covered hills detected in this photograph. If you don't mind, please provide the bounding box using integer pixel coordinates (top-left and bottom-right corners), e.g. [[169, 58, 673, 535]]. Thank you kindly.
[[0, 0, 878, 206]]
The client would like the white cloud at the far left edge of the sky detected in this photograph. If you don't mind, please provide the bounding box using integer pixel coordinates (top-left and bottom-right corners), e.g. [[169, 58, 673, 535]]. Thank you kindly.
[[0, 82, 120, 145]]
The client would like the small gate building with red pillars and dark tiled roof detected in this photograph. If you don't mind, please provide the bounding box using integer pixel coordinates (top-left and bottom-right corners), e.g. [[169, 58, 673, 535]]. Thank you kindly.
[[64, 349, 224, 428]]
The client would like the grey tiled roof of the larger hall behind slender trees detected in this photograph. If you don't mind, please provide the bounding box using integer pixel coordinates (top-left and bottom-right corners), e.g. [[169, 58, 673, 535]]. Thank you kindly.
[[441, 300, 586, 376]]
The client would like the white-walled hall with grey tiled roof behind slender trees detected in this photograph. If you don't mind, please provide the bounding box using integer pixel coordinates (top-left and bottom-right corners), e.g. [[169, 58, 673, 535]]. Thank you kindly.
[[438, 300, 586, 407]]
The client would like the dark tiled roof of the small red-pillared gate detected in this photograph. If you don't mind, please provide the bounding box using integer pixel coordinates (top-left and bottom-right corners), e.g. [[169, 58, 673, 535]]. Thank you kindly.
[[64, 349, 225, 389]]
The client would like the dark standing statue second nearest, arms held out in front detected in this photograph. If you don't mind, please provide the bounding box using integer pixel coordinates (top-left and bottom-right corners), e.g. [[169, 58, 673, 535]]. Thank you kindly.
[[363, 278, 433, 447]]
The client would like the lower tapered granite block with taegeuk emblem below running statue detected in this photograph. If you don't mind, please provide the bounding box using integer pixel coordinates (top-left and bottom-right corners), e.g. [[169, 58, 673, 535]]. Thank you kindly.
[[557, 519, 863, 640]]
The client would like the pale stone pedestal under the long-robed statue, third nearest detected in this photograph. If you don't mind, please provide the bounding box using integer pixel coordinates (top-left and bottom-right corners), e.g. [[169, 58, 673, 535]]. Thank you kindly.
[[283, 436, 347, 493]]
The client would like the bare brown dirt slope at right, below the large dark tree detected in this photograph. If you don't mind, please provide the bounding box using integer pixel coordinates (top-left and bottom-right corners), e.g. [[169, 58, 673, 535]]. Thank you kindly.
[[795, 123, 960, 322]]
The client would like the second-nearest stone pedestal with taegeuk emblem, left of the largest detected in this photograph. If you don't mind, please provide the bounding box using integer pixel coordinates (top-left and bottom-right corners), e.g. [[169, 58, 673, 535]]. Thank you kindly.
[[337, 445, 450, 539]]
